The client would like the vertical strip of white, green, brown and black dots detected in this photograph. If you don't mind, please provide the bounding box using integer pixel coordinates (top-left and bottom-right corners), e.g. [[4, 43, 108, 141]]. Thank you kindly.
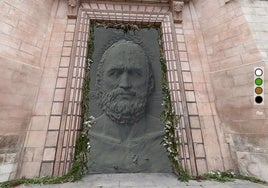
[[254, 67, 264, 105]]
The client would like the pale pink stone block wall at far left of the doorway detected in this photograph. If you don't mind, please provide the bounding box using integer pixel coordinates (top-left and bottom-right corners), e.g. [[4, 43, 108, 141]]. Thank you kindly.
[[0, 0, 53, 181]]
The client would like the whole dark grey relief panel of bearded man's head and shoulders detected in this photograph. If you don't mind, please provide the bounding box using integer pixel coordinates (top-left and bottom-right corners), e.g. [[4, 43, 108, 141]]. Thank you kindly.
[[88, 28, 171, 173]]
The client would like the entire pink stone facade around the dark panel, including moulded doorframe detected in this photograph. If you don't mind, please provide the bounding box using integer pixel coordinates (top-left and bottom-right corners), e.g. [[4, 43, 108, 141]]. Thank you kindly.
[[0, 0, 268, 181]]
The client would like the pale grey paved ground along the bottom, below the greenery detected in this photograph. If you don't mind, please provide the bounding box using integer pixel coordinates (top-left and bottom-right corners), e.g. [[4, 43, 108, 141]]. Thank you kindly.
[[20, 173, 268, 188]]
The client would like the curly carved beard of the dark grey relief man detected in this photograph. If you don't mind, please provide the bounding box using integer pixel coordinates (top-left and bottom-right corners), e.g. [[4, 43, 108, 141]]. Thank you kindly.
[[100, 89, 147, 125]]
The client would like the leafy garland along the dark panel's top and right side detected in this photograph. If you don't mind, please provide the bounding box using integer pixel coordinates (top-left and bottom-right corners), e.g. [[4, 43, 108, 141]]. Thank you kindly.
[[91, 22, 190, 181]]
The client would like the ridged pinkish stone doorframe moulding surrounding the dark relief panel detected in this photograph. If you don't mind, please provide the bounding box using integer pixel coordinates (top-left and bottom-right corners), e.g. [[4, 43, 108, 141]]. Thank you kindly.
[[44, 1, 206, 176]]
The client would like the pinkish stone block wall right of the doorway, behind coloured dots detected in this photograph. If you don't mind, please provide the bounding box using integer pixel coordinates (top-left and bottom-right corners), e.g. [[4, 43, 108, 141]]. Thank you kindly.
[[189, 0, 268, 180]]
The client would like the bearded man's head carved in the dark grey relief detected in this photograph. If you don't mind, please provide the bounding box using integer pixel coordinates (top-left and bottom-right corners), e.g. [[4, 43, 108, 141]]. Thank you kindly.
[[97, 40, 154, 125]]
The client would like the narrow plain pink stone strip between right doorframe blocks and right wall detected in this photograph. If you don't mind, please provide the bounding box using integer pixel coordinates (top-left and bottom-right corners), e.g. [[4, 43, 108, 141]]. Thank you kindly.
[[179, 1, 235, 173]]
